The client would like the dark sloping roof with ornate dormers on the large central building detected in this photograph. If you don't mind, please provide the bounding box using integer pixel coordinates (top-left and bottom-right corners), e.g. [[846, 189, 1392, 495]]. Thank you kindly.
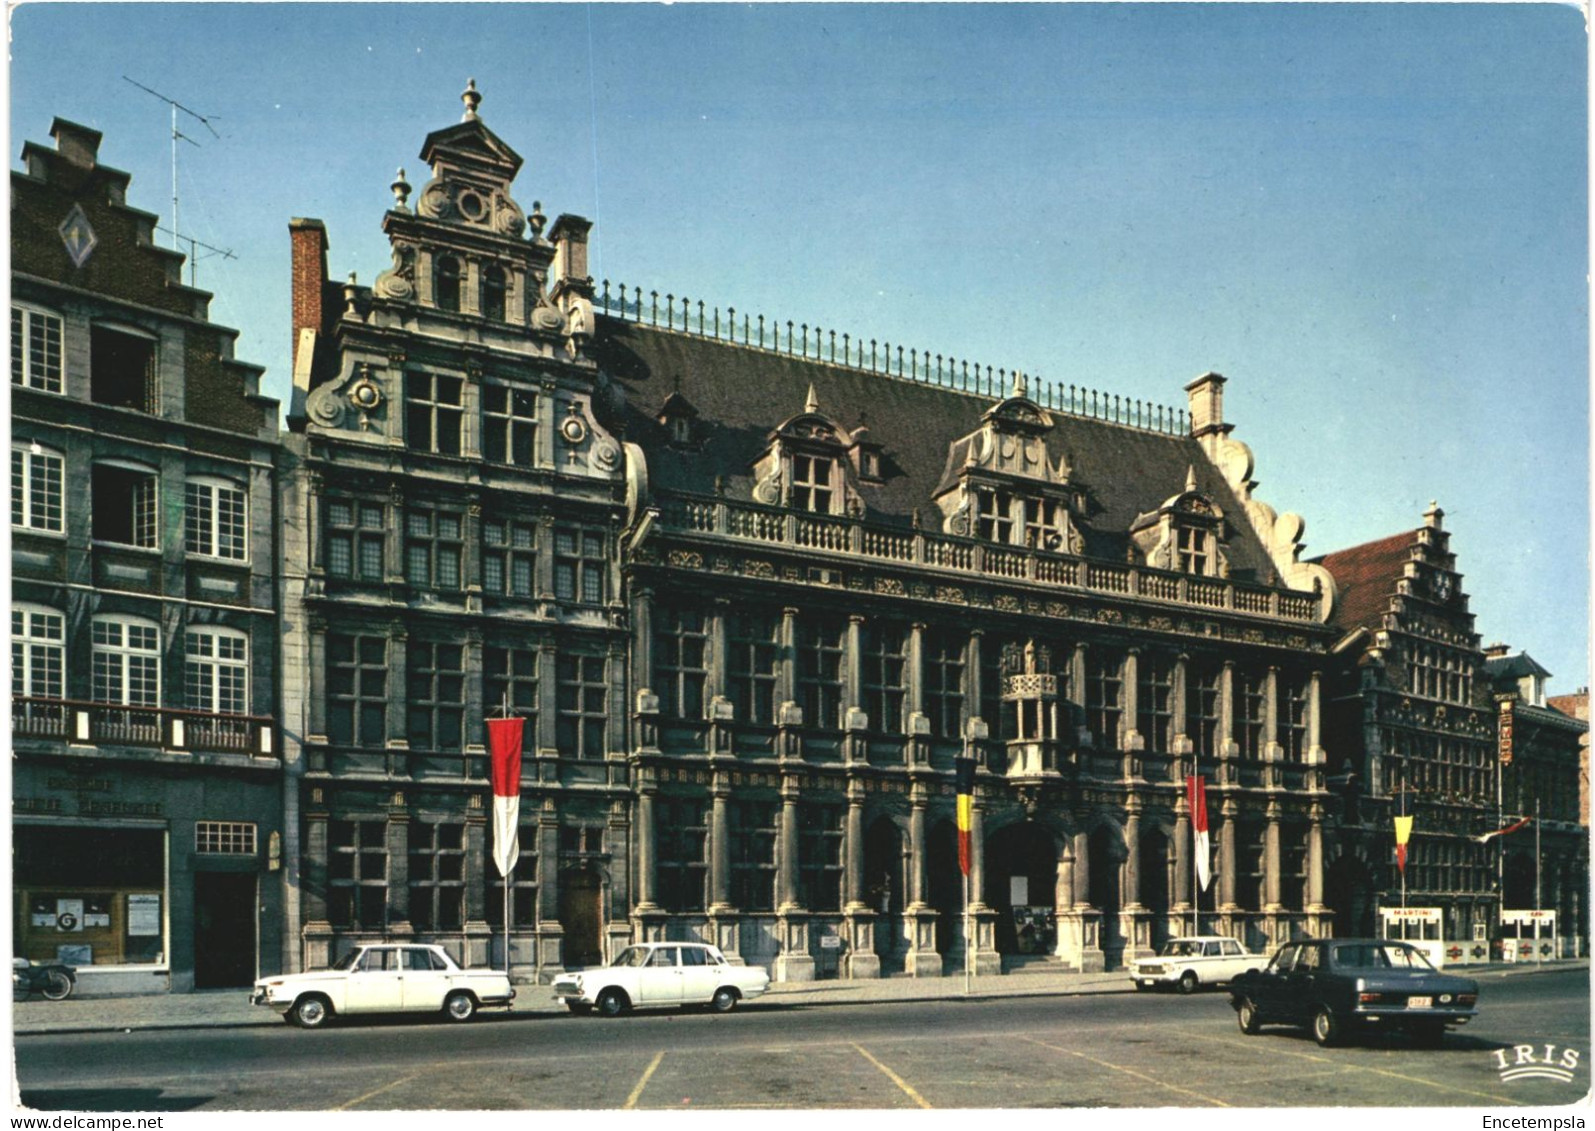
[[593, 317, 1274, 582]]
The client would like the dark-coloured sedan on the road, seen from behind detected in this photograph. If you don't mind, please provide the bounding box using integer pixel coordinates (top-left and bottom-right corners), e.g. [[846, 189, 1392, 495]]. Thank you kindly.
[[1230, 938, 1479, 1045]]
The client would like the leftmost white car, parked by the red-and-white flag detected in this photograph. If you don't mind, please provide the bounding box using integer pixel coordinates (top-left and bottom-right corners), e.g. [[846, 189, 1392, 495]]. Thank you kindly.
[[249, 944, 515, 1029]]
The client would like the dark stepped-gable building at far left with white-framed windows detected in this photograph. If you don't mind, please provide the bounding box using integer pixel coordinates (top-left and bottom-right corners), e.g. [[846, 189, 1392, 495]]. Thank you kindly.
[[11, 120, 282, 992]]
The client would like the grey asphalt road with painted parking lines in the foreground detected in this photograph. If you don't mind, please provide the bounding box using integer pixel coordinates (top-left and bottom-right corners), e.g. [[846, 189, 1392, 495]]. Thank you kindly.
[[16, 970, 1590, 1112]]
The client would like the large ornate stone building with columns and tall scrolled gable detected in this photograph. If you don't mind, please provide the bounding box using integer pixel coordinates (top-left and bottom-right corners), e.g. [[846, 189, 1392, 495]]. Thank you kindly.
[[282, 88, 1337, 979]]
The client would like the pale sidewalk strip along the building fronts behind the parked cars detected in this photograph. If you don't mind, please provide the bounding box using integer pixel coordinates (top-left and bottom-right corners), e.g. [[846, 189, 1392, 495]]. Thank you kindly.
[[11, 959, 1589, 1037]]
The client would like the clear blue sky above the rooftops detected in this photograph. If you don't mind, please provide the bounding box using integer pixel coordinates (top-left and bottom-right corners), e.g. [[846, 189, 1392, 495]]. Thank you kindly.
[[10, 3, 1589, 692]]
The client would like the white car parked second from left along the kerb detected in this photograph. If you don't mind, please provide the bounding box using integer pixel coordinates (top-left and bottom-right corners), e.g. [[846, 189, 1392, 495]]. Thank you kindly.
[[553, 943, 770, 1018]]
